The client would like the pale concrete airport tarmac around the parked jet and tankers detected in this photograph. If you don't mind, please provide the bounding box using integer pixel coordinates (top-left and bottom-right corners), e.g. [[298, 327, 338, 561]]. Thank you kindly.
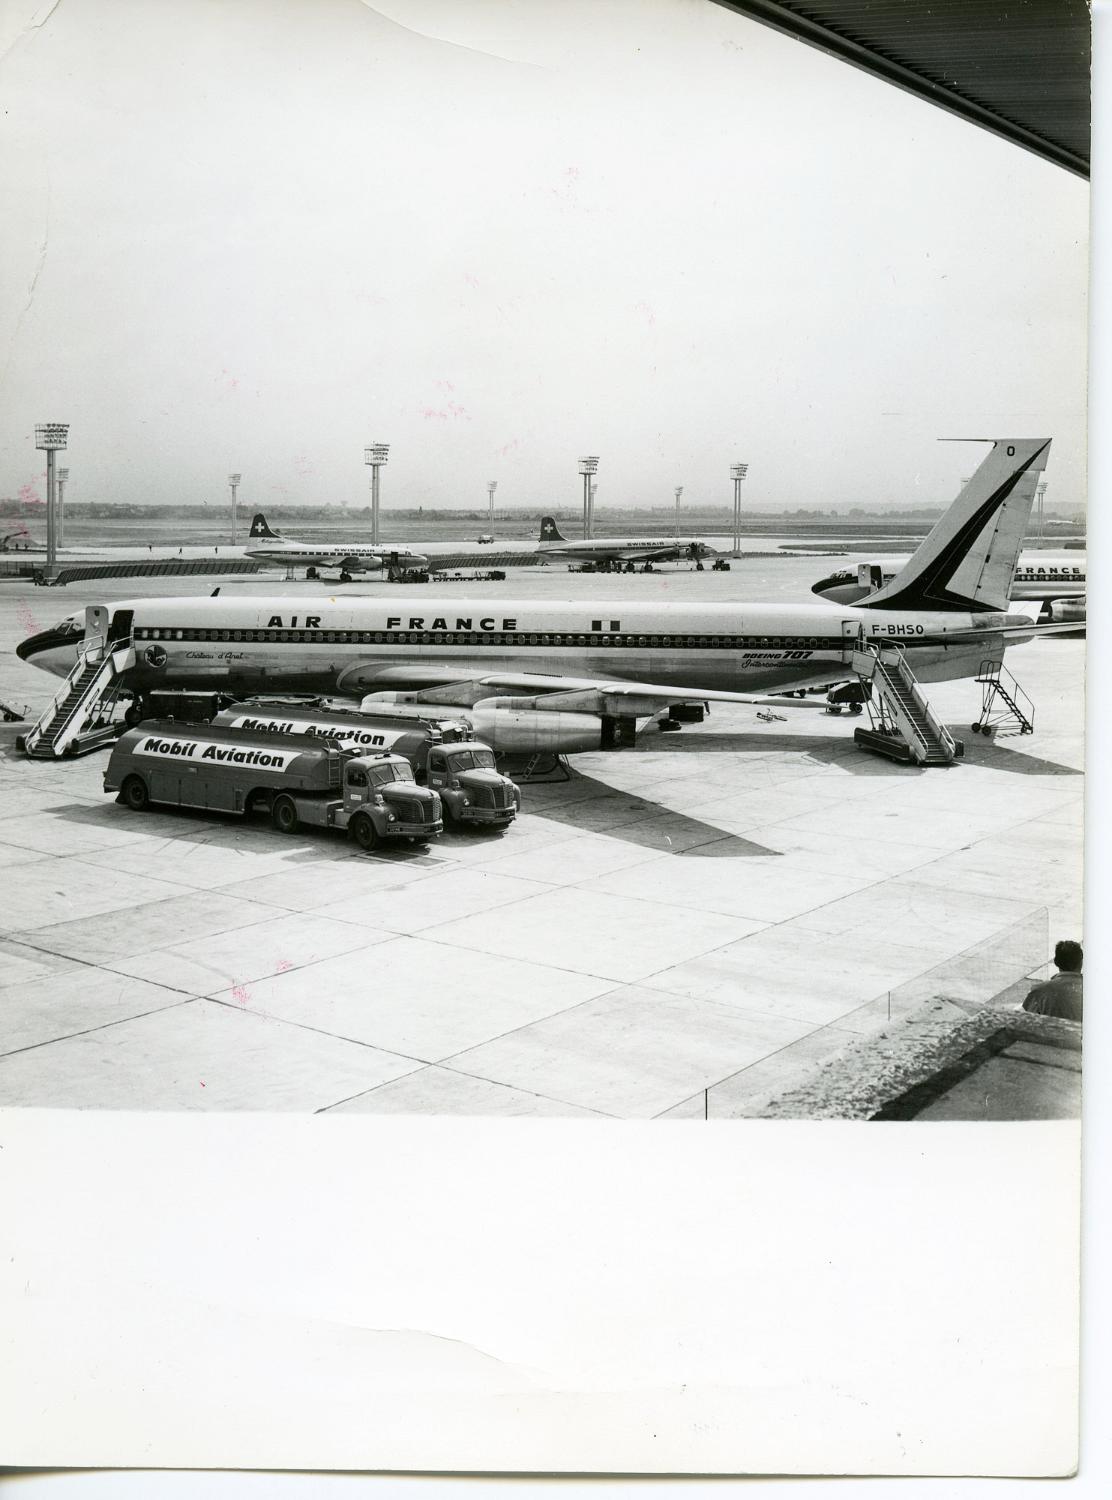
[[0, 558, 1085, 1118]]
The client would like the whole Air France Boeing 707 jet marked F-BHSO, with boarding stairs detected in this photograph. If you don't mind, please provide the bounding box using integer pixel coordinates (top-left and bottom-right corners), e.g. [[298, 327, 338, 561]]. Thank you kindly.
[[18, 438, 1059, 750]]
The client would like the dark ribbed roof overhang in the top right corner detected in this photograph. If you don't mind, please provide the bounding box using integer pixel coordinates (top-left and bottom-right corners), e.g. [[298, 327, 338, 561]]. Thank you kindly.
[[717, 0, 1091, 177]]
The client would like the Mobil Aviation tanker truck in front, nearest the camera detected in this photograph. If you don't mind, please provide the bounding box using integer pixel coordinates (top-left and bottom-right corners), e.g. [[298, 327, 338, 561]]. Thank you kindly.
[[104, 720, 444, 849]]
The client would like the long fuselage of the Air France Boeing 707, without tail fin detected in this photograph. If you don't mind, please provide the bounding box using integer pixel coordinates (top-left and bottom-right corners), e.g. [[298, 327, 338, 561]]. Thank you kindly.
[[18, 596, 1026, 693]]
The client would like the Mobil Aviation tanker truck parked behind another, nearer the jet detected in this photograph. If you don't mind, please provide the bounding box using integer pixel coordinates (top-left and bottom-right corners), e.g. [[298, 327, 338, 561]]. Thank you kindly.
[[215, 699, 521, 828]]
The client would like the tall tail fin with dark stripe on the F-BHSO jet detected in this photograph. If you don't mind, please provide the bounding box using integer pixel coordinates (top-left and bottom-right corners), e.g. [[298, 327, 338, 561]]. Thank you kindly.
[[860, 438, 1050, 612]]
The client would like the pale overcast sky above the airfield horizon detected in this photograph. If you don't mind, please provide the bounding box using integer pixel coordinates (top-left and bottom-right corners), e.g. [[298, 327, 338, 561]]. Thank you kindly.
[[0, 0, 1088, 515]]
